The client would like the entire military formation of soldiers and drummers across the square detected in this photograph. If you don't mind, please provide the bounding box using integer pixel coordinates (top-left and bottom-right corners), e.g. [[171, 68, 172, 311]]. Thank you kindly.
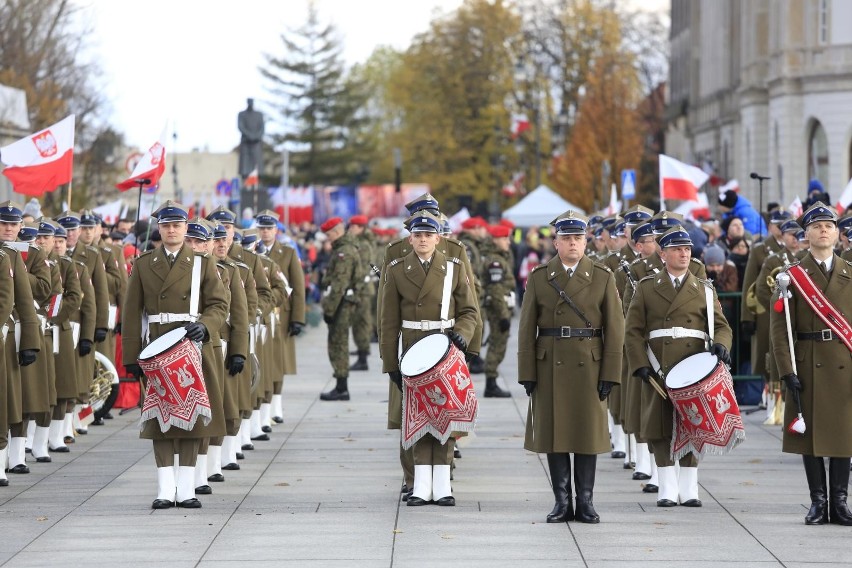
[[0, 193, 852, 525]]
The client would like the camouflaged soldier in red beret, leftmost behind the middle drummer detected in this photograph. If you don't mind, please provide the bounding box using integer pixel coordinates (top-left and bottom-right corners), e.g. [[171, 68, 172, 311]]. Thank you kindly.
[[320, 217, 366, 400]]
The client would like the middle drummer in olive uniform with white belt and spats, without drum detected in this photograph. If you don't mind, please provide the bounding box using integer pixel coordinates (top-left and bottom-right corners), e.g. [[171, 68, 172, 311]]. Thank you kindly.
[[379, 211, 479, 506]]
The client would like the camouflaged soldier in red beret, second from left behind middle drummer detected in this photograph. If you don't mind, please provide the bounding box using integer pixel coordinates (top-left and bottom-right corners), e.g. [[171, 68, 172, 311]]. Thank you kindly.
[[347, 215, 376, 371]]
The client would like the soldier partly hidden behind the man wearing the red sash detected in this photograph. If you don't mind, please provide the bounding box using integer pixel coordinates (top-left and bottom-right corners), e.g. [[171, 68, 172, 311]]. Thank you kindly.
[[754, 219, 802, 426]]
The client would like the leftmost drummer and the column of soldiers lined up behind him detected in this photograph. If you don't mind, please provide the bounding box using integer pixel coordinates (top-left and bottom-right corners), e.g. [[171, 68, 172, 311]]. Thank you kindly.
[[122, 205, 305, 509]]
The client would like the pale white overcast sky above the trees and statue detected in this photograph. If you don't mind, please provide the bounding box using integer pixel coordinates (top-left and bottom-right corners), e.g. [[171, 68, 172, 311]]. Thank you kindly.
[[79, 0, 668, 158]]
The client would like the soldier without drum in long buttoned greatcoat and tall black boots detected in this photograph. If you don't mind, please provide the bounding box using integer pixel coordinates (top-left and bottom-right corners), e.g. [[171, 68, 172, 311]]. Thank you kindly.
[[518, 211, 624, 523]]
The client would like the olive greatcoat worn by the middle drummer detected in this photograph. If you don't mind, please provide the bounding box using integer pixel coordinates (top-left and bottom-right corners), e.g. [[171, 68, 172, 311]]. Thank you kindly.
[[379, 245, 480, 429]]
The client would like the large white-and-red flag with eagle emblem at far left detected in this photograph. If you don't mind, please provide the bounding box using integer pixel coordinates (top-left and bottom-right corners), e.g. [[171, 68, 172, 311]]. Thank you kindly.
[[0, 114, 74, 197]]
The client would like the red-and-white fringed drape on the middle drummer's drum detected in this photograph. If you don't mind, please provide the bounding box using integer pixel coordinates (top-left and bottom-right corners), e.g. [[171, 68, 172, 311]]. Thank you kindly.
[[402, 345, 479, 450]]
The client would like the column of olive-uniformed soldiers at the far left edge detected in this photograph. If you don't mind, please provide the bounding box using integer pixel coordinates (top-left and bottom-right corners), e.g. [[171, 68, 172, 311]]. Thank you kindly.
[[0, 201, 127, 486]]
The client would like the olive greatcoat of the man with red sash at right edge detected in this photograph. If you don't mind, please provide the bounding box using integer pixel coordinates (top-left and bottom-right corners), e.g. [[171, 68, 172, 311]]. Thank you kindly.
[[769, 254, 852, 458]]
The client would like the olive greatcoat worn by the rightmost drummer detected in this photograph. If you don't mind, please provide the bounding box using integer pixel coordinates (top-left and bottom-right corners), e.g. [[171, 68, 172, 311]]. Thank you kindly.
[[625, 270, 733, 440]]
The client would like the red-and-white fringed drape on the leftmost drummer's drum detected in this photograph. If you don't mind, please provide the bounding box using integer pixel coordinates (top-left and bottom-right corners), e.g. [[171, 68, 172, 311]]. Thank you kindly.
[[139, 340, 213, 432]]
